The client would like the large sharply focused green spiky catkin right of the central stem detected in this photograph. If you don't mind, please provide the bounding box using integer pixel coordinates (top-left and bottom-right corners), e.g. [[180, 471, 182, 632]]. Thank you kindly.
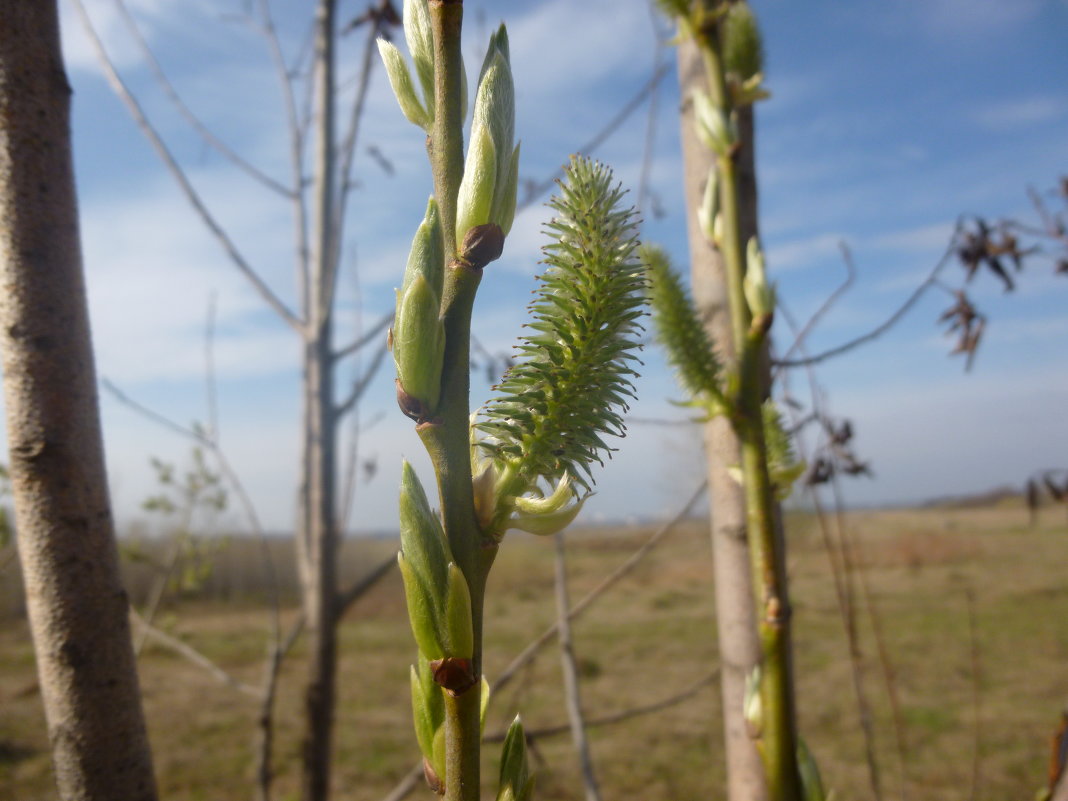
[[477, 158, 645, 490]]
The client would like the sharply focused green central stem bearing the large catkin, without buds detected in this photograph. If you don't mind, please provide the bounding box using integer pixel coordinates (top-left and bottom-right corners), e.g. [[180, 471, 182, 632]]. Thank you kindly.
[[418, 0, 497, 801]]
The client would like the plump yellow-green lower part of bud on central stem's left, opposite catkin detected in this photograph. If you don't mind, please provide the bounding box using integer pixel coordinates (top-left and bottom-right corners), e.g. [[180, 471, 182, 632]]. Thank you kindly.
[[393, 272, 445, 417]]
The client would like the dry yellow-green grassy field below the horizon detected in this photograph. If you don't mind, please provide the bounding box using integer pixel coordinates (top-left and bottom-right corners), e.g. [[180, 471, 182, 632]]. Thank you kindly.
[[0, 507, 1068, 801]]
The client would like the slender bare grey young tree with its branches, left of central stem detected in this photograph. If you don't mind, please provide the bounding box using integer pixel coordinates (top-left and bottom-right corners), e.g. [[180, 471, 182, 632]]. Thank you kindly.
[[76, 0, 399, 801]]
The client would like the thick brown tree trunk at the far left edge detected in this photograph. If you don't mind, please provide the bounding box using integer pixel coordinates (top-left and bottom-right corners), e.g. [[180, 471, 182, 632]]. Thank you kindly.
[[0, 0, 156, 801]]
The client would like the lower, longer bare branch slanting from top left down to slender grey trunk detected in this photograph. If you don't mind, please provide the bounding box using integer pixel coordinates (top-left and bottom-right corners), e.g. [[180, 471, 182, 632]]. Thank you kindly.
[[74, 0, 303, 331]]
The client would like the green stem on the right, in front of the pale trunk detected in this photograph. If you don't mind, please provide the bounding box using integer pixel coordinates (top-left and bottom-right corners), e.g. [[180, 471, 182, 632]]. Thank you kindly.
[[695, 12, 802, 801]]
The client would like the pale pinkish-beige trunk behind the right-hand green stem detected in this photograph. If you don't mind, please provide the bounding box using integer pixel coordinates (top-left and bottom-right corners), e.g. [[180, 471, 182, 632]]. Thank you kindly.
[[678, 41, 767, 801]]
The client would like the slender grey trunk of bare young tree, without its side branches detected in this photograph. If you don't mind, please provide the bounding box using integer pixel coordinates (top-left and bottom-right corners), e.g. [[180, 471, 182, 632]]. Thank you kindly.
[[301, 0, 340, 801]]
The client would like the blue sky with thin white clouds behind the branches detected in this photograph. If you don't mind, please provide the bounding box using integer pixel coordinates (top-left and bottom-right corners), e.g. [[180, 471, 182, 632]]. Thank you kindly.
[[45, 0, 1068, 540]]
